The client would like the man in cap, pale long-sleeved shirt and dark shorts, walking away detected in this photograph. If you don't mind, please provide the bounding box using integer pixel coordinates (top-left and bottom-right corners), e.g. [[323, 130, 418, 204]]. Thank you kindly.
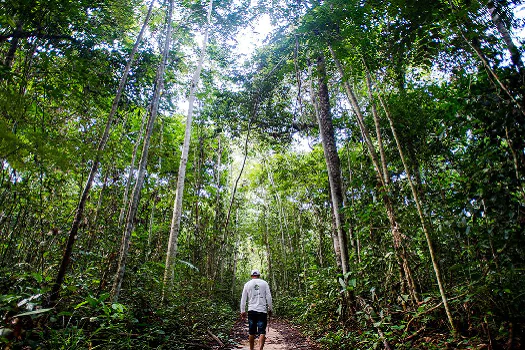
[[241, 270, 272, 350]]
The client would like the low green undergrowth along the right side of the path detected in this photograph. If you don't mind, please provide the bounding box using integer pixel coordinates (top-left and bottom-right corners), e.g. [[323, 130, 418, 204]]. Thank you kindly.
[[275, 269, 523, 350]]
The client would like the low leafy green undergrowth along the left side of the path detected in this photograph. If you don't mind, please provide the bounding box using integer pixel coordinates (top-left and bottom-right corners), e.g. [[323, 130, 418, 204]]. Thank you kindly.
[[0, 271, 236, 350]]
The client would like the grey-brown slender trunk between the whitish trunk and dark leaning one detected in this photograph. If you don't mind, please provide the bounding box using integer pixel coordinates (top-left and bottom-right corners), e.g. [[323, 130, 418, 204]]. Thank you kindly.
[[111, 0, 174, 301]]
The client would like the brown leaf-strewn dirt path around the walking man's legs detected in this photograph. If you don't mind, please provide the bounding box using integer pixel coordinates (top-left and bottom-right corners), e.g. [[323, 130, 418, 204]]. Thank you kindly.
[[228, 319, 319, 350]]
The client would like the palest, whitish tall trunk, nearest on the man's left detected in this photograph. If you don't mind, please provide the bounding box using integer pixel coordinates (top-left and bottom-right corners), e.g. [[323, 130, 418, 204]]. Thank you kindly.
[[163, 0, 213, 296]]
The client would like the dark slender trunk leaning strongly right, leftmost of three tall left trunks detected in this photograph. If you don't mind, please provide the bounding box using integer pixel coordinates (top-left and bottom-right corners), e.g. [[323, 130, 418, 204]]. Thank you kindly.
[[49, 0, 155, 304]]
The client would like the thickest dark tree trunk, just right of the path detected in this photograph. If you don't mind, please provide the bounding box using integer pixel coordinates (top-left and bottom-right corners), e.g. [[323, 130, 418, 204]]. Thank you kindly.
[[317, 55, 349, 276]]
